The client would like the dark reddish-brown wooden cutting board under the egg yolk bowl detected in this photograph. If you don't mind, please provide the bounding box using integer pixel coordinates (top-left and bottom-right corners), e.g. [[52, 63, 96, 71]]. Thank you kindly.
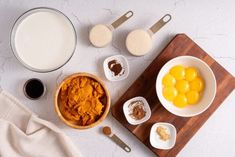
[[112, 34, 235, 157]]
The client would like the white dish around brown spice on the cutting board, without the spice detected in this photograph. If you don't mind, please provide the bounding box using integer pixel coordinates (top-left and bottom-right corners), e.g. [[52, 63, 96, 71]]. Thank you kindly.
[[123, 96, 151, 125]]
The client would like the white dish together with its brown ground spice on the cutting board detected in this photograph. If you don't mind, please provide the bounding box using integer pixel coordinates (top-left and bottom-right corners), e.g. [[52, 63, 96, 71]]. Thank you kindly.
[[123, 96, 151, 125]]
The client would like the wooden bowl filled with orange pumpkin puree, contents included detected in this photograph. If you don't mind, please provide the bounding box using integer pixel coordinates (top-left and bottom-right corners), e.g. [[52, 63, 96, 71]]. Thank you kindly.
[[55, 73, 111, 129]]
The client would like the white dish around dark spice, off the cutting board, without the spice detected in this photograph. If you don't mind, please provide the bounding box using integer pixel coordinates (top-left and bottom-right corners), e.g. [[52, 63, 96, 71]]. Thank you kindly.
[[103, 55, 130, 81]]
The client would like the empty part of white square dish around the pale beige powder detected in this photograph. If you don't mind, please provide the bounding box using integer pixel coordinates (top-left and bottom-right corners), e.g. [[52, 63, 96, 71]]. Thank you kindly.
[[150, 122, 177, 149]]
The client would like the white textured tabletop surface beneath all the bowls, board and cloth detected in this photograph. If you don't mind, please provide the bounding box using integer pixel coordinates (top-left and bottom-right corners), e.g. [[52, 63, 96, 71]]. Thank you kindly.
[[0, 0, 235, 157]]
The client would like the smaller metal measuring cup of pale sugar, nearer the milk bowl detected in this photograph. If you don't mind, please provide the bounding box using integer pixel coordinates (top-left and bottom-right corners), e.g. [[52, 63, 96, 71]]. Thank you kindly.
[[89, 11, 133, 47]]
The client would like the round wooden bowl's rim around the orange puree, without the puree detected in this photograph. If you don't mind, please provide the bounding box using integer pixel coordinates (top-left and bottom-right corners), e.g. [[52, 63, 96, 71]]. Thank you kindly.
[[54, 72, 111, 129]]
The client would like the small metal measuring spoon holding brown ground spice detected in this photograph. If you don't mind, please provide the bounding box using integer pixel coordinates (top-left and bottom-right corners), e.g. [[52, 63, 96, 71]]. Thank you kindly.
[[103, 126, 131, 153]]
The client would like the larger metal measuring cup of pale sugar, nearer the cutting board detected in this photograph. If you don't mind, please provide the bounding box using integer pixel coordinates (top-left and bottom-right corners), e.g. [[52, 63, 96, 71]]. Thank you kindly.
[[126, 14, 171, 56]]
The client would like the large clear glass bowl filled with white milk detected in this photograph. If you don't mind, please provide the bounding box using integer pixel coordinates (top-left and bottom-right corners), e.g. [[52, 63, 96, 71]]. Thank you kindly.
[[10, 7, 77, 72]]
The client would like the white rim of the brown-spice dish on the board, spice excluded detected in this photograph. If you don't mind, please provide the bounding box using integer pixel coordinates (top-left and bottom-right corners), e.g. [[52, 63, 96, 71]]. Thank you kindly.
[[123, 96, 151, 125]]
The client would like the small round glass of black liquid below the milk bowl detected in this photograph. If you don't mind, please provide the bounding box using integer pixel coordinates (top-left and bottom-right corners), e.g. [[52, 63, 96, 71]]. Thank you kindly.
[[24, 78, 46, 100]]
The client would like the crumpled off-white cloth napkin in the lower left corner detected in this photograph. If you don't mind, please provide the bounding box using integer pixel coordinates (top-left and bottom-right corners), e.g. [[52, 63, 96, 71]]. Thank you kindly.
[[0, 89, 81, 157]]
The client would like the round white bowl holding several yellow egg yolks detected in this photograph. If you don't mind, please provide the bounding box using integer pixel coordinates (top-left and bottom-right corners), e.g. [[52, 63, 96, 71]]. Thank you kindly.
[[156, 56, 216, 117]]
